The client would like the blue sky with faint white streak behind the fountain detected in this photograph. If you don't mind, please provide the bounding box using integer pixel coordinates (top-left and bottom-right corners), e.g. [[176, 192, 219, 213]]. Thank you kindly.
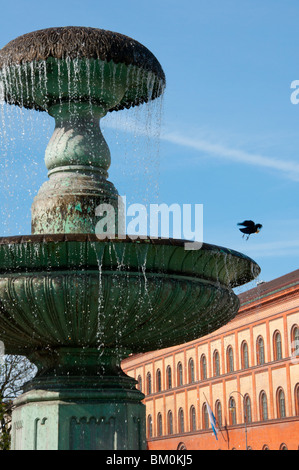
[[0, 0, 299, 287]]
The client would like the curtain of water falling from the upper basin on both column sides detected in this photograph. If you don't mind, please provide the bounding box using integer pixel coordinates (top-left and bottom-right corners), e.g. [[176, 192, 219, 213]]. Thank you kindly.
[[0, 59, 164, 239]]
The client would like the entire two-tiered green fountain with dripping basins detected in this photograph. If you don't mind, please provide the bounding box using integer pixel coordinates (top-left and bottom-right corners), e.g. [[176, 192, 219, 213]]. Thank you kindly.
[[0, 27, 259, 450]]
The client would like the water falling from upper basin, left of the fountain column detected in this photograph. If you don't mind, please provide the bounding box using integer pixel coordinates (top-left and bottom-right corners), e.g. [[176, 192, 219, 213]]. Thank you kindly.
[[0, 102, 53, 236]]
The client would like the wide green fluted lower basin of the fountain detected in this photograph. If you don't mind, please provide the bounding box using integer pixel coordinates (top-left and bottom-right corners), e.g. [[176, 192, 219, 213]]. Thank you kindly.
[[0, 234, 260, 355]]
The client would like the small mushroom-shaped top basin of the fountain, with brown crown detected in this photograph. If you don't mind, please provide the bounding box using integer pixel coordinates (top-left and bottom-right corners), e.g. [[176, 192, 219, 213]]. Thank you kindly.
[[0, 26, 165, 112]]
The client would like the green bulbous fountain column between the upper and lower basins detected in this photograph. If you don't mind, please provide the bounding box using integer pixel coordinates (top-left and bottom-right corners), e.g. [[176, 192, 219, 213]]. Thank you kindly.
[[31, 102, 118, 234]]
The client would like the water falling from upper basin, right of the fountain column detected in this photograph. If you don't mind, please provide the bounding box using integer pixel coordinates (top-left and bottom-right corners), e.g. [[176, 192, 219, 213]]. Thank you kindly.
[[102, 69, 163, 215]]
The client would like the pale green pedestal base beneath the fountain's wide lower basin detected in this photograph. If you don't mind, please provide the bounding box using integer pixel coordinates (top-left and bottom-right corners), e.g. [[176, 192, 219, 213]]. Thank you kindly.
[[12, 351, 146, 450]]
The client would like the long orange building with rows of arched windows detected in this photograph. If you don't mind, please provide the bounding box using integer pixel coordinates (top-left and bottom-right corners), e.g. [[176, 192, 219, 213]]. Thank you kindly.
[[123, 269, 299, 450]]
